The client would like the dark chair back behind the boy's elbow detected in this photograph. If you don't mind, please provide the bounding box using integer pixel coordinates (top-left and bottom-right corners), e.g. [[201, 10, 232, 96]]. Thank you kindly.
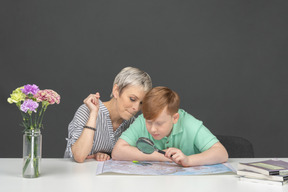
[[216, 135, 254, 158]]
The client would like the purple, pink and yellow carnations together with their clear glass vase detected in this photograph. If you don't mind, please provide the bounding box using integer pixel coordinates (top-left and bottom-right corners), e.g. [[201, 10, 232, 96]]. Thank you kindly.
[[7, 84, 60, 178]]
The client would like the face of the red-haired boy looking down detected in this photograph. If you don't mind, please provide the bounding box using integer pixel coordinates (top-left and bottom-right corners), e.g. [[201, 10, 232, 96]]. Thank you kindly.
[[145, 107, 179, 140]]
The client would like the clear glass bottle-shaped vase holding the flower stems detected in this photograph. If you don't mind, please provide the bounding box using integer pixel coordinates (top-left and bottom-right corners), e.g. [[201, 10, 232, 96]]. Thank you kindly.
[[22, 129, 42, 178]]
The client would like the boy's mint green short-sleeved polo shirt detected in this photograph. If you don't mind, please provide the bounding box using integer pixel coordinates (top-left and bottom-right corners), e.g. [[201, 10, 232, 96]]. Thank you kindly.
[[120, 109, 218, 156]]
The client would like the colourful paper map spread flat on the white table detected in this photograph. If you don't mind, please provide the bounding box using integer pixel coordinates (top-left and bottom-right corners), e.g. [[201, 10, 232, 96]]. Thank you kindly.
[[96, 160, 235, 175]]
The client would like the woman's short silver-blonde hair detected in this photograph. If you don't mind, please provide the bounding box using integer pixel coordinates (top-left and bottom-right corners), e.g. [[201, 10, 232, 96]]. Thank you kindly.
[[110, 67, 152, 98]]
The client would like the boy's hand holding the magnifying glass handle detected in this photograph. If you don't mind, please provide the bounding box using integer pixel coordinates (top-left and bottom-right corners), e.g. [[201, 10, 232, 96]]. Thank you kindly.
[[165, 148, 189, 167]]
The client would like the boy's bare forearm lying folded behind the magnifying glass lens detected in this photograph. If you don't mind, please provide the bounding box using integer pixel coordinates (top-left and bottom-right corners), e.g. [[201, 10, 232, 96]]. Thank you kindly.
[[112, 138, 170, 161]]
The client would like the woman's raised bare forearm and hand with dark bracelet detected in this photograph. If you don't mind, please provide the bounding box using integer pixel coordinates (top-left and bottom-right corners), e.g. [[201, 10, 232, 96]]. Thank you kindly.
[[71, 93, 100, 163]]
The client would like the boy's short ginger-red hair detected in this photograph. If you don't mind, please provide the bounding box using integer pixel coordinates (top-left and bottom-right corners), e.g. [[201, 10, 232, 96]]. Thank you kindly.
[[142, 87, 180, 120]]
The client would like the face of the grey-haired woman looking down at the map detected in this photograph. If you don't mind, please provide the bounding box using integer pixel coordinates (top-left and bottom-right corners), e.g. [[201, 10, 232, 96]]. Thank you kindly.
[[114, 86, 146, 120]]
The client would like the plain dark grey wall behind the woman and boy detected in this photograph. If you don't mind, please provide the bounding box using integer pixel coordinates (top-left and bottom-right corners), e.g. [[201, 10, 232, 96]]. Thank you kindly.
[[0, 0, 288, 158]]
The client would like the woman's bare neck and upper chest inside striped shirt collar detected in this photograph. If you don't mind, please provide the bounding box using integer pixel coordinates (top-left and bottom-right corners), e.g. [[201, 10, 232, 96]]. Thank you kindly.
[[103, 98, 123, 131]]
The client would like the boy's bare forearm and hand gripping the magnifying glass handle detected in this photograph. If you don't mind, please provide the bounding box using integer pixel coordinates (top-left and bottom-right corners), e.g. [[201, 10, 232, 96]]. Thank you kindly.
[[165, 142, 228, 167]]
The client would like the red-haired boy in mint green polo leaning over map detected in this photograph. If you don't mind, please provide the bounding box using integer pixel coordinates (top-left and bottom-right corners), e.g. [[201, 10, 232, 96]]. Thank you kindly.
[[112, 87, 228, 167]]
